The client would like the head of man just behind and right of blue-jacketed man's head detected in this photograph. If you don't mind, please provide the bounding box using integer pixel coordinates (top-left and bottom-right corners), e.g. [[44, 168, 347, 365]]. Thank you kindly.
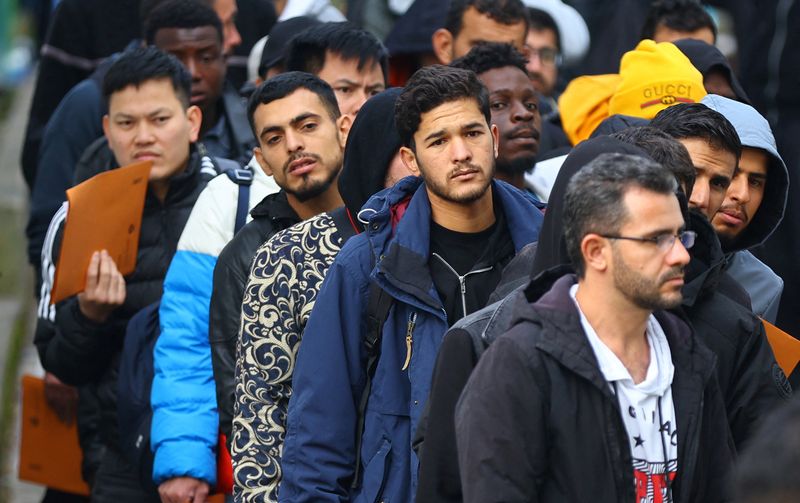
[[450, 43, 542, 195]]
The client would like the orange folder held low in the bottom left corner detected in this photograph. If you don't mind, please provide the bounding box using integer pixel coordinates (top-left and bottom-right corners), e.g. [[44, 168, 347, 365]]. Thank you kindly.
[[19, 375, 89, 495]]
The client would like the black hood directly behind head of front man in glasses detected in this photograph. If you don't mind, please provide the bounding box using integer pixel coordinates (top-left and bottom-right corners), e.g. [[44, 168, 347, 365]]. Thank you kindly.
[[533, 136, 650, 276]]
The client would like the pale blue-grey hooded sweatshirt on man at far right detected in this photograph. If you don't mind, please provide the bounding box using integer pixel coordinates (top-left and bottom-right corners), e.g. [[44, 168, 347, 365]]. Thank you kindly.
[[702, 94, 789, 323]]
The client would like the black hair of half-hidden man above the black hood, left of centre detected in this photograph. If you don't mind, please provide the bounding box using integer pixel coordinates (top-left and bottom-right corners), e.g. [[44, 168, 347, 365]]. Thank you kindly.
[[285, 21, 389, 81]]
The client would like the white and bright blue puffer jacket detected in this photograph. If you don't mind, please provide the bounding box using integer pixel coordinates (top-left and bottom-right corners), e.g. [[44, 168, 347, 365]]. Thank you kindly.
[[151, 159, 280, 486]]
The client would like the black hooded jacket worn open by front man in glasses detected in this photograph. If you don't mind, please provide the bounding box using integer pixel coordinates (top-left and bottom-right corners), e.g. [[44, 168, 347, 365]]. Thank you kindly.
[[454, 275, 735, 503]]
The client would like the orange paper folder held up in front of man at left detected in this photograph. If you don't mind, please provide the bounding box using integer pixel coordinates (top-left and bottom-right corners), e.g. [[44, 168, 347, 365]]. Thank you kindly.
[[50, 161, 153, 304]]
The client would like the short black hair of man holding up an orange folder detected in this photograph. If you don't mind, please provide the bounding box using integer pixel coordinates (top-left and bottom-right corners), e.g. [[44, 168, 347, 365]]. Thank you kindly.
[[103, 46, 192, 109]]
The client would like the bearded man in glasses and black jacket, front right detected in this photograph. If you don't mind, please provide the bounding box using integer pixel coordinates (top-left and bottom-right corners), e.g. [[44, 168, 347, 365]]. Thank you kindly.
[[455, 154, 734, 502]]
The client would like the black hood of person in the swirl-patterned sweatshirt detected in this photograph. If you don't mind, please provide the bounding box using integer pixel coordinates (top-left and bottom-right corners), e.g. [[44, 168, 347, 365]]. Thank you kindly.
[[339, 87, 402, 220]]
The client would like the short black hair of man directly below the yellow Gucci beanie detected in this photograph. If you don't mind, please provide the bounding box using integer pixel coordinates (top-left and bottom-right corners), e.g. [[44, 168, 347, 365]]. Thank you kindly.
[[650, 103, 742, 159]]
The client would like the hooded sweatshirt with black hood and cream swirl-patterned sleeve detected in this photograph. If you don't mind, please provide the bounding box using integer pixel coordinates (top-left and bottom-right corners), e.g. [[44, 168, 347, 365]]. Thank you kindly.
[[227, 88, 401, 501]]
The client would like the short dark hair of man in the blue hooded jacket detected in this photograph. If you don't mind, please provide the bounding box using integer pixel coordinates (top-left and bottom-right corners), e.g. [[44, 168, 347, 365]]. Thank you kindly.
[[394, 65, 492, 150]]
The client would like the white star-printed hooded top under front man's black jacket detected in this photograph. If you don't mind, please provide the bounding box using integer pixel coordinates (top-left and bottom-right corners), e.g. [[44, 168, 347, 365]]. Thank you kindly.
[[569, 285, 678, 503]]
